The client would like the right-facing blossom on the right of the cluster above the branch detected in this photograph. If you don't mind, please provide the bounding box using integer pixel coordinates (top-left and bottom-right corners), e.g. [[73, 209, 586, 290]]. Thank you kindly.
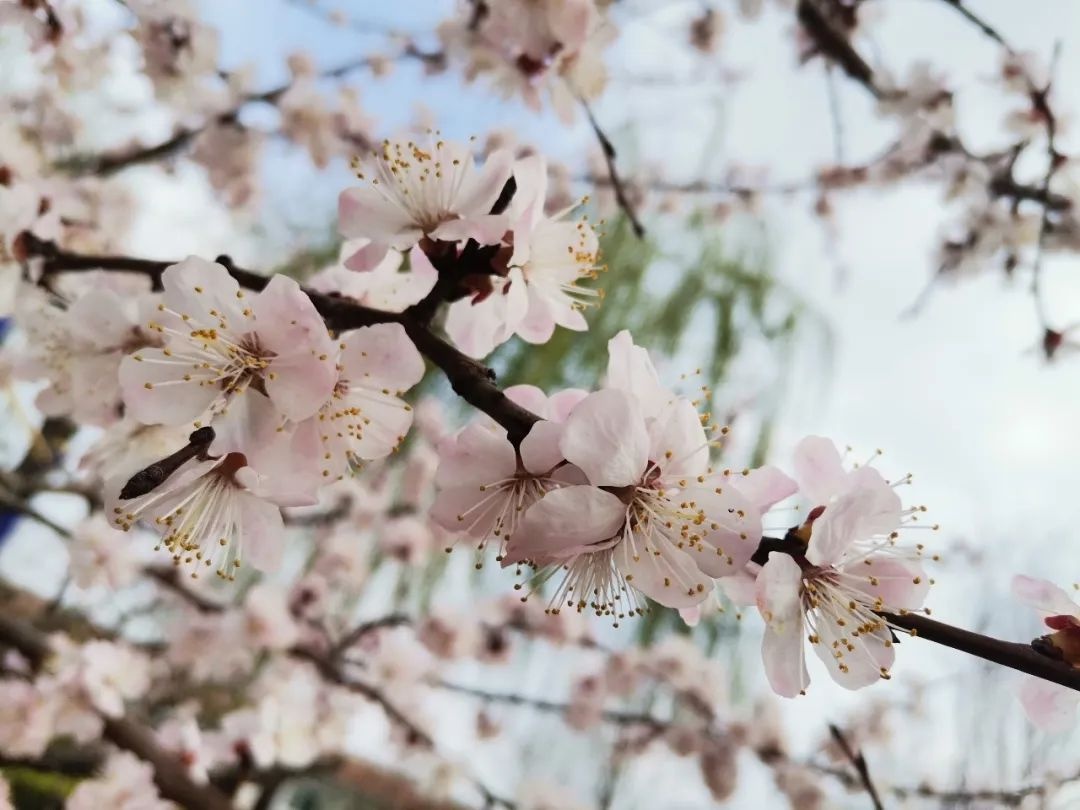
[[446, 157, 603, 357]]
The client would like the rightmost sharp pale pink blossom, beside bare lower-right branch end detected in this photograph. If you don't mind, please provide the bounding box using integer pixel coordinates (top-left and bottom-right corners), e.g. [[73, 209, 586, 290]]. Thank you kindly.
[[756, 436, 930, 698]]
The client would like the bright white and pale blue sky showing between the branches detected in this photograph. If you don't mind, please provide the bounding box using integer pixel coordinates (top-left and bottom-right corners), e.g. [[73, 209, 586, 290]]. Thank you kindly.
[[3, 0, 1080, 808]]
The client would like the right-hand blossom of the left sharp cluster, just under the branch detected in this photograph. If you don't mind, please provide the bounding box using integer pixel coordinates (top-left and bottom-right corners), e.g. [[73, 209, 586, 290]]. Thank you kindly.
[[297, 323, 424, 482]]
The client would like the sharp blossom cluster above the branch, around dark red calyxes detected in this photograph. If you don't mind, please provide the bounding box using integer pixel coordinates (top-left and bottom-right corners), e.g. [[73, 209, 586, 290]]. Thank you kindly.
[[336, 139, 602, 357]]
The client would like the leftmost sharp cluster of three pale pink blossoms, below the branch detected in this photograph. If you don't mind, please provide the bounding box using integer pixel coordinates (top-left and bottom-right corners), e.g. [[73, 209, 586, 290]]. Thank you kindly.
[[101, 257, 423, 578]]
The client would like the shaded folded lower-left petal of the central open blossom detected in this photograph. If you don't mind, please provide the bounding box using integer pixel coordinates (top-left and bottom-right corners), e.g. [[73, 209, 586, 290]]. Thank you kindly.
[[503, 486, 626, 566]]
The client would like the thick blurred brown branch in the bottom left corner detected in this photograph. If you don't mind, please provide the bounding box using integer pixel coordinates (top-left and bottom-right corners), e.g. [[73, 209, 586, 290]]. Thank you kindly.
[[0, 612, 232, 810]]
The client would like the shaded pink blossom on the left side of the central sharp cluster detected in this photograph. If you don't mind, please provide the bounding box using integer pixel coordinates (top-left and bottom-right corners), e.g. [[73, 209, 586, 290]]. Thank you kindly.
[[431, 386, 585, 548]]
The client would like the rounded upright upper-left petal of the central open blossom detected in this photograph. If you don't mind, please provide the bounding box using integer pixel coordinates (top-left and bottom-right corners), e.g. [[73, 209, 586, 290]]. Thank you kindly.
[[559, 390, 649, 487]]
